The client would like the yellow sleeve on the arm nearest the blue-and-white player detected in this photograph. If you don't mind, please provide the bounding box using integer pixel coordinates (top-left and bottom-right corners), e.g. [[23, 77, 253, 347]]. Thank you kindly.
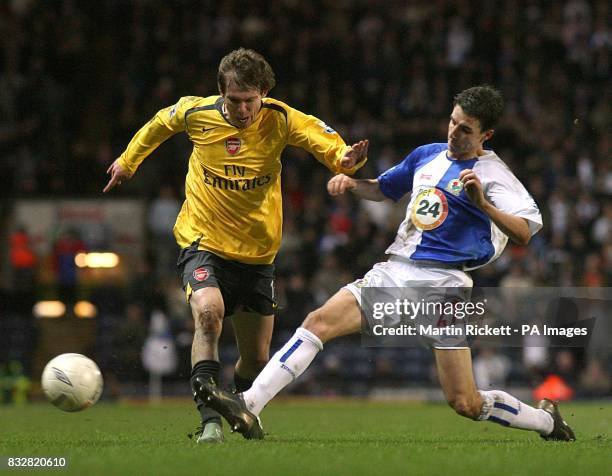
[[287, 108, 367, 175]]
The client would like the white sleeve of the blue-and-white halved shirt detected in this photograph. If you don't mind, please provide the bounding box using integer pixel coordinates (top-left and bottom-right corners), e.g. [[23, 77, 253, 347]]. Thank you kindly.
[[475, 161, 543, 236]]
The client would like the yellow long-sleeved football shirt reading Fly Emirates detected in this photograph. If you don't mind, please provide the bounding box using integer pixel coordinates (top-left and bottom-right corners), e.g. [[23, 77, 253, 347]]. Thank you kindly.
[[119, 96, 365, 264]]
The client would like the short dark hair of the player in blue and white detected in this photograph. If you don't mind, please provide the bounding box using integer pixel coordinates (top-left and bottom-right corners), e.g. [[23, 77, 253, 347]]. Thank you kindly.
[[453, 84, 504, 131]]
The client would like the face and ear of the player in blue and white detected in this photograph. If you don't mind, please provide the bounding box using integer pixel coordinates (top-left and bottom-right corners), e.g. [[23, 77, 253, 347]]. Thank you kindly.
[[448, 106, 493, 160]]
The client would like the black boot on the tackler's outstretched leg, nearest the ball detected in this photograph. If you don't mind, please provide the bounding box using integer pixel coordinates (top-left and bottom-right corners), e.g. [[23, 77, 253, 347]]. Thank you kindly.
[[194, 377, 264, 440]]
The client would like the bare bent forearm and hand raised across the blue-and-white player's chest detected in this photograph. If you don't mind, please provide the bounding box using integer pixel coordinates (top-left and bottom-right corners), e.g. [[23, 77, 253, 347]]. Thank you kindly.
[[459, 169, 532, 246]]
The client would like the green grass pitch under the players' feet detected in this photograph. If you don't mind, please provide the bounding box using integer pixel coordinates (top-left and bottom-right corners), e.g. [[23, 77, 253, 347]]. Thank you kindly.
[[0, 400, 612, 476]]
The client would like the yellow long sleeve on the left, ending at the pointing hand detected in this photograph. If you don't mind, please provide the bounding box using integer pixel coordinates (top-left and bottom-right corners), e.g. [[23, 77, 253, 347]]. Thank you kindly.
[[119, 97, 196, 175]]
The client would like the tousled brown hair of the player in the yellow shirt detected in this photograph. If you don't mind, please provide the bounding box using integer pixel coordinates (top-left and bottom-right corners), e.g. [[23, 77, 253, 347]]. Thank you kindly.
[[217, 48, 276, 94]]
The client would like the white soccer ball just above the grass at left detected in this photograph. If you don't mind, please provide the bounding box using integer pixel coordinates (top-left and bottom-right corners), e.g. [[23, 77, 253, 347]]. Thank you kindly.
[[41, 354, 104, 412]]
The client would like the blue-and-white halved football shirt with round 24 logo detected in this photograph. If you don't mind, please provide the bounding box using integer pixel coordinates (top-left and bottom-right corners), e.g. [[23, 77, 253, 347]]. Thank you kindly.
[[378, 143, 542, 271]]
